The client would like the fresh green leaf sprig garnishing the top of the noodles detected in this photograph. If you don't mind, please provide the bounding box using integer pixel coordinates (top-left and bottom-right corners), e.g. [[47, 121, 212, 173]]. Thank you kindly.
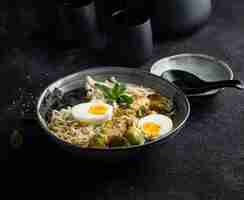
[[95, 81, 133, 106]]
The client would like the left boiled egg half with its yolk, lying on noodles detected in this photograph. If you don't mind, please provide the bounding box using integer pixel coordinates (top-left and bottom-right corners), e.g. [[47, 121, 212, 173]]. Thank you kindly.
[[72, 102, 113, 123]]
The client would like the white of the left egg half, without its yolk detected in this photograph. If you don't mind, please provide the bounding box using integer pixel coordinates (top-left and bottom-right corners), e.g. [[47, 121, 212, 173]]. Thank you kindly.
[[71, 102, 113, 123]]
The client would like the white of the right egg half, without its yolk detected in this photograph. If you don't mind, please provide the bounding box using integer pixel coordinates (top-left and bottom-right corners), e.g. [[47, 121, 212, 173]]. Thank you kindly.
[[138, 114, 173, 139]]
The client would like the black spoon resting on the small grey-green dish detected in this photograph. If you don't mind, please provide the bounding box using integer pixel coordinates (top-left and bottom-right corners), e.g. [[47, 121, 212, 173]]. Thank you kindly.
[[162, 70, 244, 95]]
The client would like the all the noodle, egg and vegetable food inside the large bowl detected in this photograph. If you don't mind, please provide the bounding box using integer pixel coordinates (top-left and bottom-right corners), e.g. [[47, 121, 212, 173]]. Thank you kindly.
[[48, 76, 175, 148]]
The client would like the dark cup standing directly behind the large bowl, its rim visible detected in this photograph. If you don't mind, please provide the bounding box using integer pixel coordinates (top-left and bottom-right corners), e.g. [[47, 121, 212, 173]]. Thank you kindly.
[[109, 9, 153, 66]]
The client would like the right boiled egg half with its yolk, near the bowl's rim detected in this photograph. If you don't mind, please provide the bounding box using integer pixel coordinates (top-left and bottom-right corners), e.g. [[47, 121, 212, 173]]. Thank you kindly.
[[138, 114, 173, 140]]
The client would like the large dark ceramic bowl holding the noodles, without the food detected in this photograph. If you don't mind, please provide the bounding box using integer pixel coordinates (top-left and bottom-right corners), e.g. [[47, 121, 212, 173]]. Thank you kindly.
[[37, 67, 190, 161]]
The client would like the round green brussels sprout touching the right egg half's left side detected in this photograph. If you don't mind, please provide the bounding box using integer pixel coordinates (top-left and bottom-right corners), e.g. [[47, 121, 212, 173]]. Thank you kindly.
[[126, 126, 145, 145]]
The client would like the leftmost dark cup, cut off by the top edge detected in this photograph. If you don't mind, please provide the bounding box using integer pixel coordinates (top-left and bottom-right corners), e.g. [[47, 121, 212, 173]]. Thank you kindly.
[[58, 0, 100, 48]]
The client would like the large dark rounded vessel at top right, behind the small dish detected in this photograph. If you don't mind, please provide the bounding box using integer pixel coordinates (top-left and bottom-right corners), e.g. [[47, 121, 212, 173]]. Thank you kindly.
[[152, 0, 212, 36]]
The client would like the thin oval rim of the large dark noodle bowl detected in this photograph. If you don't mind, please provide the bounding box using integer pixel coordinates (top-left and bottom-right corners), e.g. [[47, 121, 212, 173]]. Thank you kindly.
[[36, 66, 191, 152]]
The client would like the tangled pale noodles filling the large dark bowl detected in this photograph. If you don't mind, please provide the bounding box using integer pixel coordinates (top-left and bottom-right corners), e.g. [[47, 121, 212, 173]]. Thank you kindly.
[[48, 77, 173, 148]]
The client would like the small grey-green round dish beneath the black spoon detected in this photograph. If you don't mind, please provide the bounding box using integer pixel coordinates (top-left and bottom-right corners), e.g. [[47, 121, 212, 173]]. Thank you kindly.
[[151, 54, 233, 96]]
